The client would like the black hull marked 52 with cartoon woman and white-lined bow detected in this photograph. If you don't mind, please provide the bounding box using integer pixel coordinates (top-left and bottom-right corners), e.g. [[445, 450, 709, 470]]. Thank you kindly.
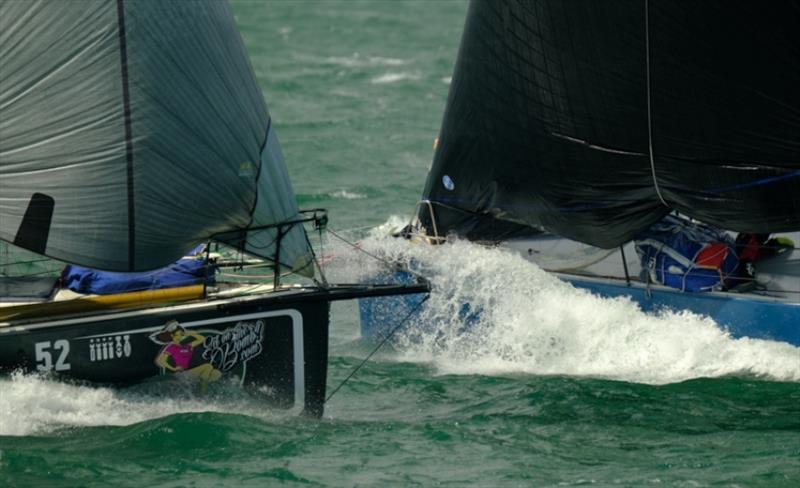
[[0, 292, 330, 416]]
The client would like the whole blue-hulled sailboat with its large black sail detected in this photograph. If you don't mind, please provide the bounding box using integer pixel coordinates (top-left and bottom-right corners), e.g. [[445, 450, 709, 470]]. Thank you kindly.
[[361, 0, 800, 346]]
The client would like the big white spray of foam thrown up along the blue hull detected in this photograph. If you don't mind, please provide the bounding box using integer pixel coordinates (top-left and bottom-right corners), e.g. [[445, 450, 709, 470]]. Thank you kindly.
[[340, 231, 800, 384]]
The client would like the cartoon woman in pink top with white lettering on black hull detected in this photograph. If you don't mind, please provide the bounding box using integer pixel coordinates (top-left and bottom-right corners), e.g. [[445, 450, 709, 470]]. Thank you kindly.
[[150, 320, 264, 385]]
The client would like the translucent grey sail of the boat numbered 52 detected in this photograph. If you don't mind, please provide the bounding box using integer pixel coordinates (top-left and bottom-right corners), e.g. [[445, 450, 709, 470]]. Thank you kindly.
[[0, 0, 310, 271]]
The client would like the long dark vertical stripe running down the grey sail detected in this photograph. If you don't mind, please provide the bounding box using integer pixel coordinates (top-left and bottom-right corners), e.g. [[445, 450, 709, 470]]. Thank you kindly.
[[117, 0, 136, 271]]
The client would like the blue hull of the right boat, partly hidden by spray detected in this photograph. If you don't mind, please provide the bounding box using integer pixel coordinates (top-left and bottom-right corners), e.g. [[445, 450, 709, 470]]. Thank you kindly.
[[359, 272, 800, 347]]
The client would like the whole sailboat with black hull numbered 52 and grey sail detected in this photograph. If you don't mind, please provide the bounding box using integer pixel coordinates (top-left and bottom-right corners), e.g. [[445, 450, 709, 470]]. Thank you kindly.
[[0, 0, 426, 415]]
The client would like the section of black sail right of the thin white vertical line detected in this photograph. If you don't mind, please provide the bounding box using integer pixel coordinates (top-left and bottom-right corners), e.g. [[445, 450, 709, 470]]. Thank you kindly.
[[650, 1, 800, 232]]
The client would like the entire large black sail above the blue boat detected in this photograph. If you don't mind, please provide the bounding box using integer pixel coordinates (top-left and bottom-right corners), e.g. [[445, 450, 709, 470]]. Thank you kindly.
[[419, 0, 800, 248]]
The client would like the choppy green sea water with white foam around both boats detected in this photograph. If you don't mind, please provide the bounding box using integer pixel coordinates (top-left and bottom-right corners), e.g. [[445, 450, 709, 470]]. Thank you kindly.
[[0, 0, 800, 487]]
